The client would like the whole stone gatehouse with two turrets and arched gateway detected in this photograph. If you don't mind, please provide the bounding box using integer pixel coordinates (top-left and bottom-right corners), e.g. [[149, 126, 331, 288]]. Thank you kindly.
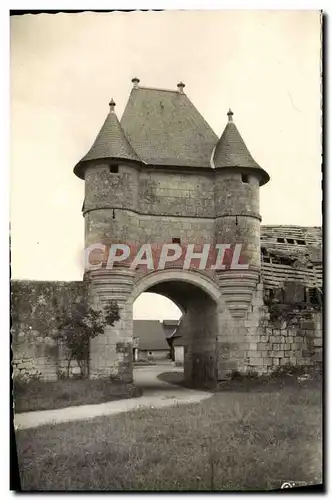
[[74, 78, 269, 384]]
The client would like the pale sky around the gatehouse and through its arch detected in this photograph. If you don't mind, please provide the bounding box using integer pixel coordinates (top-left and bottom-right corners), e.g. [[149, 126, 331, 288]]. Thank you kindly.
[[11, 11, 321, 319]]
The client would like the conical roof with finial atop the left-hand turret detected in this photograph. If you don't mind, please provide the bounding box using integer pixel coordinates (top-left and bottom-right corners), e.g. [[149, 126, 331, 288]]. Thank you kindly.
[[74, 99, 142, 179]]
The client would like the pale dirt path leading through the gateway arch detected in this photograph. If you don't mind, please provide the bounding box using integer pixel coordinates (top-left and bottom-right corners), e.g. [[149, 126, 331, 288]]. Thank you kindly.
[[14, 363, 212, 429]]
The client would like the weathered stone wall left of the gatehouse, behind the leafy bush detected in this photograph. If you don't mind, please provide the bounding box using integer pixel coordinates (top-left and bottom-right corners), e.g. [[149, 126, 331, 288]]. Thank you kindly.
[[11, 280, 87, 380]]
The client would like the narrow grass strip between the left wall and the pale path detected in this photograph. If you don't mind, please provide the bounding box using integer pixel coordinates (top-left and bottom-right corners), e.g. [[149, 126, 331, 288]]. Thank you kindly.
[[13, 379, 141, 413]]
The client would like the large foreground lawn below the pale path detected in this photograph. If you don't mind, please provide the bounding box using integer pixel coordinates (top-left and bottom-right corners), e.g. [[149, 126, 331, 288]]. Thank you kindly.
[[16, 379, 322, 491]]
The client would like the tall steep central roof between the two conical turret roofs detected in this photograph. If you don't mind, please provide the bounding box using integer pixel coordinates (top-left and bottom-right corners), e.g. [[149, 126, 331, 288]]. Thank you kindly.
[[121, 87, 218, 168]]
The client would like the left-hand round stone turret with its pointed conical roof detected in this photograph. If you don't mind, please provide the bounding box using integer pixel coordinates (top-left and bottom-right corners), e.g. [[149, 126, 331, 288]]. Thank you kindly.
[[74, 99, 142, 248]]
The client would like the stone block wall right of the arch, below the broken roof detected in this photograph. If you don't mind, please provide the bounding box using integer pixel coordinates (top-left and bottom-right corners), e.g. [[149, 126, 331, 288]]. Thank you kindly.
[[220, 284, 323, 375]]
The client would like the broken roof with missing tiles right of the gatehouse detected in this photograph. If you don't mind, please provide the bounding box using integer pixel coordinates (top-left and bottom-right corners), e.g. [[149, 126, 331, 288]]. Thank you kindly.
[[261, 226, 323, 288]]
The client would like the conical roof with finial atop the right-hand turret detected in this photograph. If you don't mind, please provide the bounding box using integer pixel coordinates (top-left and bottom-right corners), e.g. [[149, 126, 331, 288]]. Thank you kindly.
[[213, 110, 270, 185]]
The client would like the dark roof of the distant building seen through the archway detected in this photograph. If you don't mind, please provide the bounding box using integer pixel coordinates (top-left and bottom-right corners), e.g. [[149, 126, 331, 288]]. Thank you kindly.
[[134, 319, 169, 351]]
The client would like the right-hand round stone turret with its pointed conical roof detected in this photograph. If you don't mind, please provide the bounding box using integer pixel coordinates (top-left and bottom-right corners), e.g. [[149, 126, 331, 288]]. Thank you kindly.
[[211, 110, 269, 269]]
